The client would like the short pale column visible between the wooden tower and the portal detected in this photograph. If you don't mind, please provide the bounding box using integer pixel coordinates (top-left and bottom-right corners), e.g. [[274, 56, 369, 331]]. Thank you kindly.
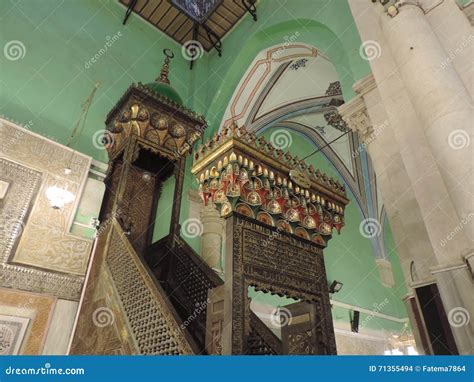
[[201, 203, 225, 273]]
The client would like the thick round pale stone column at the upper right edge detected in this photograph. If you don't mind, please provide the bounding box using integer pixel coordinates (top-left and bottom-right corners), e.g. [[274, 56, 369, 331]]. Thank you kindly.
[[380, 3, 474, 248]]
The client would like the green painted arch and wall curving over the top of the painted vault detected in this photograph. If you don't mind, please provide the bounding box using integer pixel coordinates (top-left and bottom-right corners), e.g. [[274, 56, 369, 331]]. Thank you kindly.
[[197, 0, 370, 136]]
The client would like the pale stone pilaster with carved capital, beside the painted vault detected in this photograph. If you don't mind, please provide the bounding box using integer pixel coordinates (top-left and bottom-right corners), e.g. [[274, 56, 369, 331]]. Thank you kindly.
[[339, 75, 436, 287]]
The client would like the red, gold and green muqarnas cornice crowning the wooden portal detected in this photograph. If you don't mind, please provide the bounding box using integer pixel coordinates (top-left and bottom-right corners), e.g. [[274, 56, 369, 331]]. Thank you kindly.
[[192, 124, 349, 246]]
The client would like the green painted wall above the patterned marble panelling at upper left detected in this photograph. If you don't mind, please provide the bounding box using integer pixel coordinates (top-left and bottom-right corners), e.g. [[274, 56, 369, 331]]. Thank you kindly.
[[0, 0, 201, 162]]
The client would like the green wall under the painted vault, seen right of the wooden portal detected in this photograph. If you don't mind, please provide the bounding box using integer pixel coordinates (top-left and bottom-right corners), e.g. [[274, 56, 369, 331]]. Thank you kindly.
[[249, 127, 407, 331]]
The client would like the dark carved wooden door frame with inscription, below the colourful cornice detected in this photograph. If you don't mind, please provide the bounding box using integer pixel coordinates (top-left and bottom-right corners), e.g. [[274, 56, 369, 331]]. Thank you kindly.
[[223, 213, 336, 354]]
